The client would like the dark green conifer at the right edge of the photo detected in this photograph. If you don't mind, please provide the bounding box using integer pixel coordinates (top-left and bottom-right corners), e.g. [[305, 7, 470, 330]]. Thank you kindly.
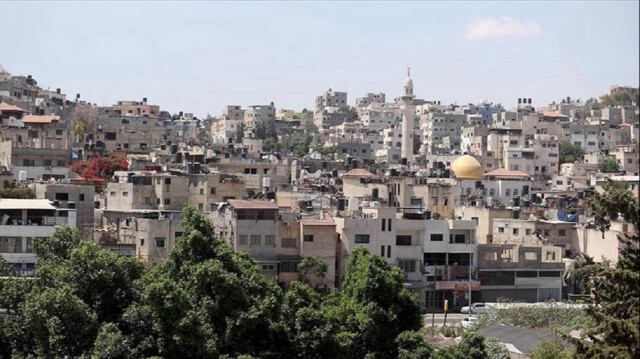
[[574, 182, 640, 359]]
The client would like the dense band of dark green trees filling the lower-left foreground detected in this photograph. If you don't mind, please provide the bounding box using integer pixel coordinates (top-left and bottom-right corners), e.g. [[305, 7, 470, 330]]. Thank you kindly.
[[0, 207, 433, 359]]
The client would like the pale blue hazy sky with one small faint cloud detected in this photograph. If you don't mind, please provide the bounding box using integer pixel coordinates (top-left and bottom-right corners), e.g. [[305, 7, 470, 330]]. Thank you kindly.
[[0, 0, 640, 116]]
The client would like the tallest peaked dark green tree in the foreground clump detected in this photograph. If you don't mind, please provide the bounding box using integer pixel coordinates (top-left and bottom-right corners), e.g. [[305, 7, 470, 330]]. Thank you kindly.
[[126, 206, 282, 358]]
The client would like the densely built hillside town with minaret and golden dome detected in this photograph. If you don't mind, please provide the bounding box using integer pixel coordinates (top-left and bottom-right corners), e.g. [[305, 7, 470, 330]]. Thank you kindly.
[[0, 67, 640, 312]]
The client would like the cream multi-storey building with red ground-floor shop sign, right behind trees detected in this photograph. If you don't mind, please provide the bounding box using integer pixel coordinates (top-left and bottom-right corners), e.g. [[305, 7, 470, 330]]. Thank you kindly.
[[334, 205, 479, 308]]
